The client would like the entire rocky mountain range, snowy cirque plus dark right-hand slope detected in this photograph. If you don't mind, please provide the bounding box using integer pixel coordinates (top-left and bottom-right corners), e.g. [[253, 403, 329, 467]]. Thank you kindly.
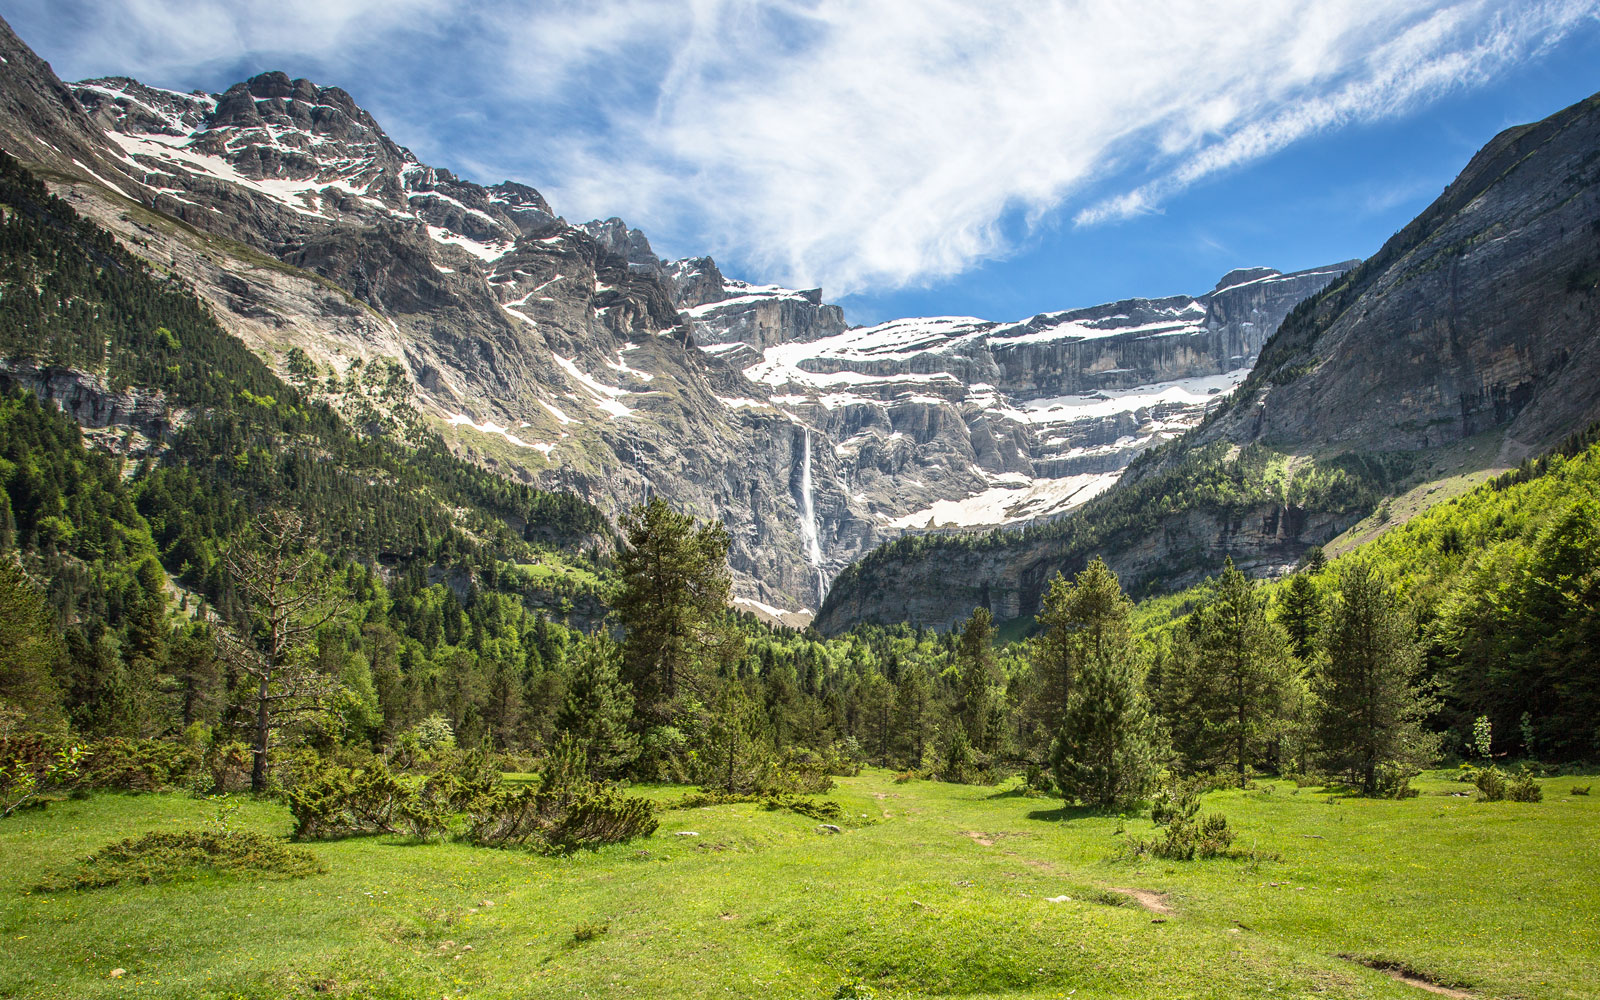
[[0, 22, 1600, 630]]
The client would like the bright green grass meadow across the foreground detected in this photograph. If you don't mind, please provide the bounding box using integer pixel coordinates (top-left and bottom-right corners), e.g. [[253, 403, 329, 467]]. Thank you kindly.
[[0, 771, 1600, 1000]]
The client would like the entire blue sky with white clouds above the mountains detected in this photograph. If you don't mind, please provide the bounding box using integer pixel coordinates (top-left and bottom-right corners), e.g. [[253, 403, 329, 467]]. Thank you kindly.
[[0, 0, 1600, 322]]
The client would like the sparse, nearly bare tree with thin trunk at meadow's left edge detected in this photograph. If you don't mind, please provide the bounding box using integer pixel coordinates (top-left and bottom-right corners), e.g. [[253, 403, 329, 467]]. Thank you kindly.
[[218, 510, 346, 792]]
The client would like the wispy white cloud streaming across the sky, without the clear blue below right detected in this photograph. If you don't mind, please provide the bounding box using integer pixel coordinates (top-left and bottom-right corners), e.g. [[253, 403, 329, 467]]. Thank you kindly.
[[12, 0, 1600, 294]]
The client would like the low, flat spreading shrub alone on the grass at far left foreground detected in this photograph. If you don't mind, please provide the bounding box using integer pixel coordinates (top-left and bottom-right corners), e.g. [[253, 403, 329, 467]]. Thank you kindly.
[[38, 830, 326, 891]]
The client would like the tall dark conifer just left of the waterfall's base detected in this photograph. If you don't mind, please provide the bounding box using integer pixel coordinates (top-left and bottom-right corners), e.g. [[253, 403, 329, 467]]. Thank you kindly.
[[613, 498, 744, 725]]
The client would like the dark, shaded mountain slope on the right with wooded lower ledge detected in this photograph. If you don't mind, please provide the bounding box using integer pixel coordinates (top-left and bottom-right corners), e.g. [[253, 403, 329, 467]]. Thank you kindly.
[[818, 87, 1600, 632]]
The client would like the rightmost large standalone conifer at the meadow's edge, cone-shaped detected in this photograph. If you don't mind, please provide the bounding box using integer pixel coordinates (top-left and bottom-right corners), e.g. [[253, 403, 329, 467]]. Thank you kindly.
[[1312, 562, 1438, 795]]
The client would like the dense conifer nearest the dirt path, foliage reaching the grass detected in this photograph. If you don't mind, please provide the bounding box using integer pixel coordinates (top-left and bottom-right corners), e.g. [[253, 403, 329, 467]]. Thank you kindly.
[[1051, 558, 1160, 808]]
